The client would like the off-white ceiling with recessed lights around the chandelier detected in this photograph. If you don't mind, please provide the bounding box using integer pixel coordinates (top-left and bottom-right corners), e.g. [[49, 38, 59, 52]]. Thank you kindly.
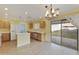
[[0, 4, 79, 19]]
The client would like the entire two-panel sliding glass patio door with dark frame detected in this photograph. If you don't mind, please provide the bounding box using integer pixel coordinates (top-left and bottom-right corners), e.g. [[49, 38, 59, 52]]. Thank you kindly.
[[51, 20, 78, 49]]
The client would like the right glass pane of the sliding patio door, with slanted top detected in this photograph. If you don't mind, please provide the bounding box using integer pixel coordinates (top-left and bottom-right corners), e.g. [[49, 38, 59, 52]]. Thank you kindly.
[[62, 21, 78, 49]]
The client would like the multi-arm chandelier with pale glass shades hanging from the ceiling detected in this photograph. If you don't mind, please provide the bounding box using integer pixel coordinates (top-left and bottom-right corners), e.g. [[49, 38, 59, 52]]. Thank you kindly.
[[45, 4, 59, 18]]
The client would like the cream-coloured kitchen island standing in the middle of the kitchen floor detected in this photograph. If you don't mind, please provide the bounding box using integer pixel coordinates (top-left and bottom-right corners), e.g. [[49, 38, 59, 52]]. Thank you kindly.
[[17, 32, 30, 47]]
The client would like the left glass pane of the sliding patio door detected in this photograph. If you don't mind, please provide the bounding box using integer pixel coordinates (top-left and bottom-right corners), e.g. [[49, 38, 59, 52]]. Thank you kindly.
[[51, 21, 61, 44]]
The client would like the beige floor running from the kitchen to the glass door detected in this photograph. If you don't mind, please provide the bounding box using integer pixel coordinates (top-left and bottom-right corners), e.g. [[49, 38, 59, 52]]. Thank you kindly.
[[0, 41, 78, 55]]
